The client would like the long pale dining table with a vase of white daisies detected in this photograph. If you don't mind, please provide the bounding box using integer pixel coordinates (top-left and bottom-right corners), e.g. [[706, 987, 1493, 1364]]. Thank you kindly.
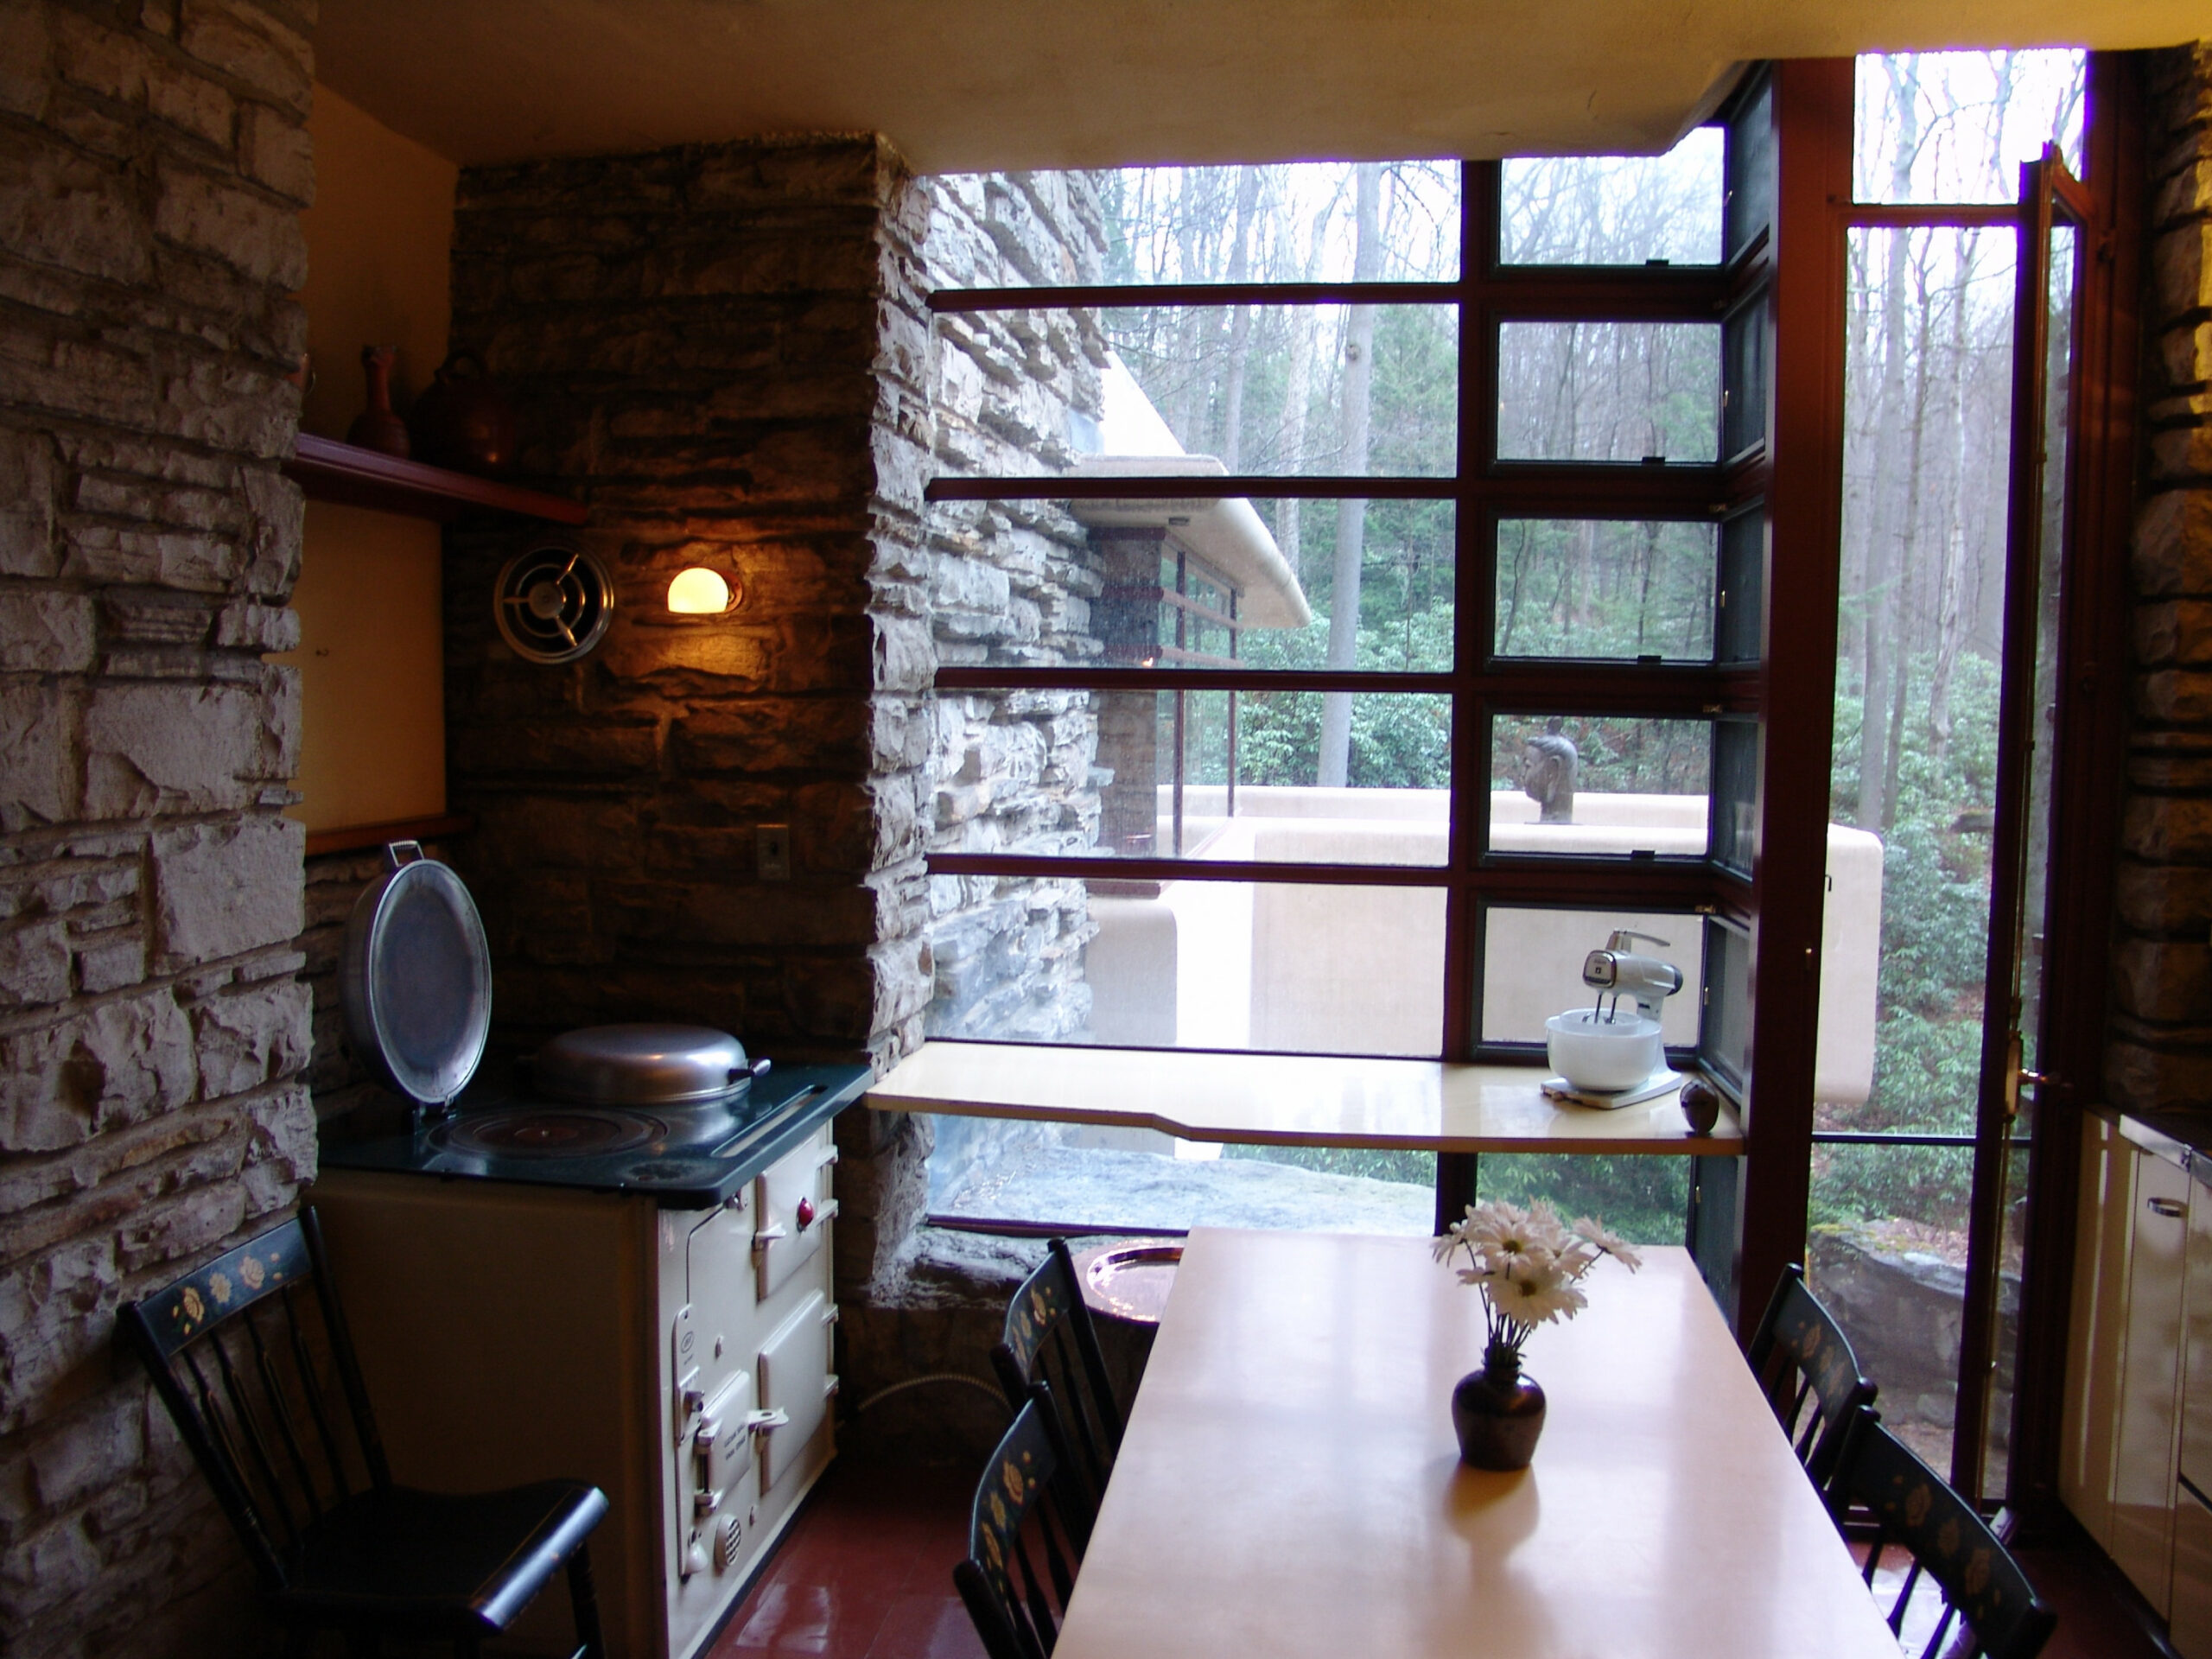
[[1055, 1228, 1897, 1659]]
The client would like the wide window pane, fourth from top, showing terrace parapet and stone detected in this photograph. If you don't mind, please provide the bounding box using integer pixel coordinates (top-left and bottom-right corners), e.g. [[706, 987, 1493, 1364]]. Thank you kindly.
[[1084, 692, 1451, 865]]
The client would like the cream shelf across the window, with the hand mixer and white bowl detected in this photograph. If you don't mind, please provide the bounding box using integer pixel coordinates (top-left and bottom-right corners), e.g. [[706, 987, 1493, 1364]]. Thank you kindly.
[[868, 1042, 1743, 1157]]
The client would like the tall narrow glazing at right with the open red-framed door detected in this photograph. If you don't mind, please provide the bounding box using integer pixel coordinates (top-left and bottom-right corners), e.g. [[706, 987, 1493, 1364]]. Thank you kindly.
[[1808, 51, 2086, 1493]]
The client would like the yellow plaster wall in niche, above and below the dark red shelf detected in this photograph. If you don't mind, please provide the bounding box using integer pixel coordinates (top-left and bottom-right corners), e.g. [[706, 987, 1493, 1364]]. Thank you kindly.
[[279, 86, 458, 830]]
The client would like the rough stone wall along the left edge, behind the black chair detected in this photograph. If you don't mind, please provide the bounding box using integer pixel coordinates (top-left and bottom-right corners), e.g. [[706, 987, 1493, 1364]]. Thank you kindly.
[[0, 0, 315, 1659]]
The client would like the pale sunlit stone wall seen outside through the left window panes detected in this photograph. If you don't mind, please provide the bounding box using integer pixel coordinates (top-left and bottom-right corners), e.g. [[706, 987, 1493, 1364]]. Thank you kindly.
[[923, 173, 1106, 1042]]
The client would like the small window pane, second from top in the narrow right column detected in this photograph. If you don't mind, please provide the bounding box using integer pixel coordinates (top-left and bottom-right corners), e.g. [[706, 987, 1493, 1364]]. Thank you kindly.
[[1497, 323, 1721, 462]]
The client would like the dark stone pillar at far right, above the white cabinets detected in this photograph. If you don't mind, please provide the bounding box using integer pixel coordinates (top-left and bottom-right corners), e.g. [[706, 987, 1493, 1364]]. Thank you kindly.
[[2106, 42, 2212, 1110]]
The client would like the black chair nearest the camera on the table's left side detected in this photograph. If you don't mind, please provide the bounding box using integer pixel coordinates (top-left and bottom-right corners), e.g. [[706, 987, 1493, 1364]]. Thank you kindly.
[[953, 1382, 1079, 1659]]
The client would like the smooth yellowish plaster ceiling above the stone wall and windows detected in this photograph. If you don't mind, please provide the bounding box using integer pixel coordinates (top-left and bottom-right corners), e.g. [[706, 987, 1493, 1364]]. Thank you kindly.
[[316, 0, 2212, 173]]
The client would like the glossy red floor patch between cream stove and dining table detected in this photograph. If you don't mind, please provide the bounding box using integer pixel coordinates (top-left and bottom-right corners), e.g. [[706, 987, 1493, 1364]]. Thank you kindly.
[[708, 1458, 982, 1659]]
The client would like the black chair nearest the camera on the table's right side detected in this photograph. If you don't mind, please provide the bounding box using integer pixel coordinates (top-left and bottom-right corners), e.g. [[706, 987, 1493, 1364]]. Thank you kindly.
[[1836, 1407, 2057, 1659]]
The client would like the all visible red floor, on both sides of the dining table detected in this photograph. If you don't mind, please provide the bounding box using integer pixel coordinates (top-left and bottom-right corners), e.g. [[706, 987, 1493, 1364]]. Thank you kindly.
[[708, 1458, 2168, 1659]]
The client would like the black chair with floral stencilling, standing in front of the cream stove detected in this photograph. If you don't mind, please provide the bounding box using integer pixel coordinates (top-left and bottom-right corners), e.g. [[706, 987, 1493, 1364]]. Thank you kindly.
[[119, 1210, 606, 1659]]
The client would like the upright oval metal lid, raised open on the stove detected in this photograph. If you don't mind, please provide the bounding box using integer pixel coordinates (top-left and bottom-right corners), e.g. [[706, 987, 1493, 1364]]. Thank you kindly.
[[339, 841, 491, 1106]]
